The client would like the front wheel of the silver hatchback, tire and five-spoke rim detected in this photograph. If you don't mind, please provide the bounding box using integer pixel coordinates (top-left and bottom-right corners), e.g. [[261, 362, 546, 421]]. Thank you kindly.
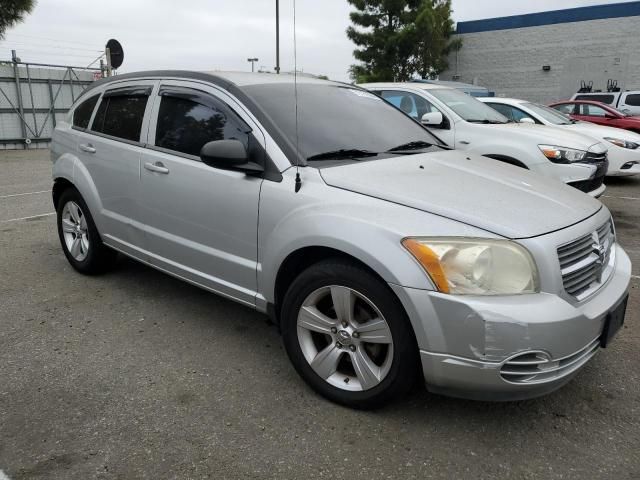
[[281, 259, 419, 409]]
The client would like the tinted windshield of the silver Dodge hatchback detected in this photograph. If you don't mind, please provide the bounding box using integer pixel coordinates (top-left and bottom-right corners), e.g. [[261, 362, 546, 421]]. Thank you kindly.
[[242, 83, 443, 165]]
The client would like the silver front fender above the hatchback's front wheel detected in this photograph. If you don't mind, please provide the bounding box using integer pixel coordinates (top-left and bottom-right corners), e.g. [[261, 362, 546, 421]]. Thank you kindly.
[[258, 169, 494, 302]]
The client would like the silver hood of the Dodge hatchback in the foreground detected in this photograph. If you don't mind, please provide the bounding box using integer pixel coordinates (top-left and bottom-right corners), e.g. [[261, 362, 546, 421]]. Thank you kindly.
[[320, 151, 602, 239]]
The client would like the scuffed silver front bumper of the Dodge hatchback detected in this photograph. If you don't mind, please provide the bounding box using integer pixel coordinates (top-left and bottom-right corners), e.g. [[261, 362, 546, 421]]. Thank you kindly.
[[392, 245, 631, 401]]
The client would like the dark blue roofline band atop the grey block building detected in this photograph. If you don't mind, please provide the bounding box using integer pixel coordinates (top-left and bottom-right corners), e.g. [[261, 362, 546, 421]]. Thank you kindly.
[[456, 1, 640, 34]]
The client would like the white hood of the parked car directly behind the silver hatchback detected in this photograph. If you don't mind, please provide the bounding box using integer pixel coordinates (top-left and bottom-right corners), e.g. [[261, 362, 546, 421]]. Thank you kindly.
[[486, 123, 599, 151]]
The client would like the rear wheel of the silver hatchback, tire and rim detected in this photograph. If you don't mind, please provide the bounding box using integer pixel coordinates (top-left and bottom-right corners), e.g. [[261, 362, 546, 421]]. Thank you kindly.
[[56, 188, 117, 275]]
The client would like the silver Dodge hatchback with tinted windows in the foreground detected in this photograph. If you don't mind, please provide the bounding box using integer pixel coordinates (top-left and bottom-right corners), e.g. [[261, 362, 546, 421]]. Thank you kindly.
[[52, 71, 631, 408]]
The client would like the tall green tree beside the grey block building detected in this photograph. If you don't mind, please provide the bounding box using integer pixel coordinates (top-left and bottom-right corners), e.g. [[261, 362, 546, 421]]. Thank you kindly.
[[347, 0, 460, 82]]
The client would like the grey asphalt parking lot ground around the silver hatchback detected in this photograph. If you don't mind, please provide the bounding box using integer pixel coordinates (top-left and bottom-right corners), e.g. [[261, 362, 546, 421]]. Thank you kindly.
[[0, 150, 640, 480]]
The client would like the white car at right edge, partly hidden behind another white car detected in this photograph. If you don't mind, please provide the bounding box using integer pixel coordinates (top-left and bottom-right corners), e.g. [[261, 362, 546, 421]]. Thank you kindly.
[[480, 98, 640, 176]]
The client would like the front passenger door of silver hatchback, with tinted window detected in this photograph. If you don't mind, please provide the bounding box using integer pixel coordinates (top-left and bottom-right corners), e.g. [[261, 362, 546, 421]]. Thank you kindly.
[[141, 80, 265, 305]]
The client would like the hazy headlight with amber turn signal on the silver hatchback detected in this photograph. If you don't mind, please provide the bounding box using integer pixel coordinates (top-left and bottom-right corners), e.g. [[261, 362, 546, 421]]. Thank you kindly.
[[402, 238, 539, 295]]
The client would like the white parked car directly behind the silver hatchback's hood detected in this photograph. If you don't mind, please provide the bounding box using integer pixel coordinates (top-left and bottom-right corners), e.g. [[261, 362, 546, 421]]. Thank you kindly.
[[361, 83, 608, 197]]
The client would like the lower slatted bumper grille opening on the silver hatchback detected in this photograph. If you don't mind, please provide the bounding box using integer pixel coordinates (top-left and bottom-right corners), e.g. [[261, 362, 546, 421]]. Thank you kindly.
[[500, 338, 600, 384]]
